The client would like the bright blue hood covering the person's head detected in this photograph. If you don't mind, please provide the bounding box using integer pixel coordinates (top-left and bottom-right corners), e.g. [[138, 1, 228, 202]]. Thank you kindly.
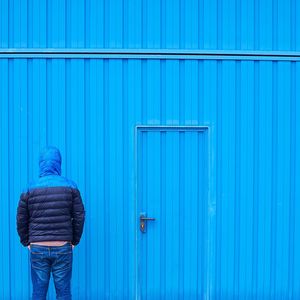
[[39, 147, 61, 177]]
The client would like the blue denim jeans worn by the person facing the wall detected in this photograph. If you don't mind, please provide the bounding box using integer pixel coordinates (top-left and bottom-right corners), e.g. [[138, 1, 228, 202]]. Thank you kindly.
[[30, 243, 73, 300]]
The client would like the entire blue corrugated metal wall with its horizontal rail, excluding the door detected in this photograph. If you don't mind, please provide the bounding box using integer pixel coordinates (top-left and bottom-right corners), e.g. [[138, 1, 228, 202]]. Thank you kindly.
[[0, 0, 300, 299]]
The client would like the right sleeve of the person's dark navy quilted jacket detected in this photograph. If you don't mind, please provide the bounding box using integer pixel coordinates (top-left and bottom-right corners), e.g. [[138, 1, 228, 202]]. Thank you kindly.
[[72, 189, 85, 245]]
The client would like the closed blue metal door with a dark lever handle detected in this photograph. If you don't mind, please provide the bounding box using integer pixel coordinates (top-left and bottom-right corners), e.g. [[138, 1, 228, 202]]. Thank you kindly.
[[136, 127, 208, 299]]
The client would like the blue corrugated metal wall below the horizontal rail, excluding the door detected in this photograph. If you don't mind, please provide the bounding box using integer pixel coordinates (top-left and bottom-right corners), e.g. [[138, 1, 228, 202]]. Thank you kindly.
[[0, 58, 300, 299]]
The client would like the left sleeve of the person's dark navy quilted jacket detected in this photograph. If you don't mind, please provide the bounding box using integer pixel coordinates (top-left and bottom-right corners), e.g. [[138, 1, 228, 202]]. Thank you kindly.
[[17, 193, 29, 246]]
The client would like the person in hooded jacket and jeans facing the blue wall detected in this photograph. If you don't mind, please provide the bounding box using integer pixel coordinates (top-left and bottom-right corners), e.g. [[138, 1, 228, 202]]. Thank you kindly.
[[17, 147, 85, 299]]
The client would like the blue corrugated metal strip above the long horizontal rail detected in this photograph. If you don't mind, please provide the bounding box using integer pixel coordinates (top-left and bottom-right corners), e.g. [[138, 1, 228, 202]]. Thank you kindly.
[[0, 0, 300, 51]]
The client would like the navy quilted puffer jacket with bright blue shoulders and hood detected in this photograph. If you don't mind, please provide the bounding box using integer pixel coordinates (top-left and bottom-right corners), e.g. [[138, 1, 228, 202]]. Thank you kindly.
[[17, 147, 85, 246]]
